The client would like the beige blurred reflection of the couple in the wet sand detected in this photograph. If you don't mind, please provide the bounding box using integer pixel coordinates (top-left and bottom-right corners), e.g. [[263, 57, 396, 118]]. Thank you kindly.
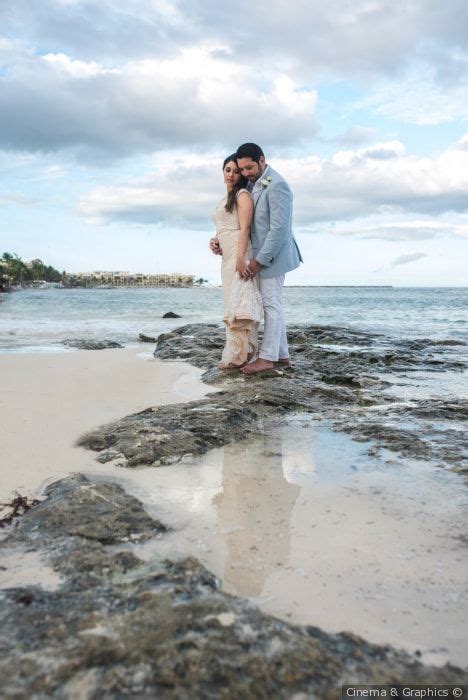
[[214, 427, 301, 596]]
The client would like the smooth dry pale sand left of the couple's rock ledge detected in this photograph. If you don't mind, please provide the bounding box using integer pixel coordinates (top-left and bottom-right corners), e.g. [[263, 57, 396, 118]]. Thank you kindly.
[[0, 349, 210, 502]]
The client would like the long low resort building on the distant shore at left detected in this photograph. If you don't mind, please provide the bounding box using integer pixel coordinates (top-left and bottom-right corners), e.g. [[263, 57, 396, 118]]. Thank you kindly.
[[70, 270, 194, 287]]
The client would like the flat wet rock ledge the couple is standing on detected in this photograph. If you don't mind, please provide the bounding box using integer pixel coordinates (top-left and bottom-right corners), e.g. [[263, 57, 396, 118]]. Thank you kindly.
[[79, 324, 468, 473]]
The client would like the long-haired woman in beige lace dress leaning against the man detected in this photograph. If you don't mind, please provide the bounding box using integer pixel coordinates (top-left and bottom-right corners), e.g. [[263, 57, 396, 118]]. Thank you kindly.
[[213, 155, 263, 369]]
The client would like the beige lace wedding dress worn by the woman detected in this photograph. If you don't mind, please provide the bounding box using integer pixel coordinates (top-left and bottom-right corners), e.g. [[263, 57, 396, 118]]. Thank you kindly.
[[213, 189, 263, 366]]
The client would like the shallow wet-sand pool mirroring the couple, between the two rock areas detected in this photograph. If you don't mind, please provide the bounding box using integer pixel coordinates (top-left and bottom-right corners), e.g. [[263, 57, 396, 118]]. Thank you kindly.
[[91, 422, 468, 665]]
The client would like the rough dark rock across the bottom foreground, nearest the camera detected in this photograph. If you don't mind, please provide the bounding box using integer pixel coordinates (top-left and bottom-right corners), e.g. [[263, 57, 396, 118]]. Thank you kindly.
[[0, 476, 468, 700]]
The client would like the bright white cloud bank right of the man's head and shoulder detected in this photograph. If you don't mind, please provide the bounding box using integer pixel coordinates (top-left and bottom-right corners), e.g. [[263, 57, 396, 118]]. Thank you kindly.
[[288, 137, 468, 226]]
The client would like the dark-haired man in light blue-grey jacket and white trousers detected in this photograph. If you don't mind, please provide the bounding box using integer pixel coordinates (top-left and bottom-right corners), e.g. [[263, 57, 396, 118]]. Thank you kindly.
[[212, 143, 302, 374]]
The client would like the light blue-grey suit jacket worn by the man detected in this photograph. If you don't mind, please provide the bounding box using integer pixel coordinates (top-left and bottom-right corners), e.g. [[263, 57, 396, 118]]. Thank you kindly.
[[250, 166, 303, 277]]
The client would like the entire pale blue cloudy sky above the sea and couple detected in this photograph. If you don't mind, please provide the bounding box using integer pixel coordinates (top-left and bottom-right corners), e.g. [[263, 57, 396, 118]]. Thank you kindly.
[[0, 0, 468, 286]]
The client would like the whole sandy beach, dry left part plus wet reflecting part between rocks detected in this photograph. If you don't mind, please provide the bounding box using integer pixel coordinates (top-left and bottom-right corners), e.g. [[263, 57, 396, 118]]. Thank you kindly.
[[0, 342, 468, 666]]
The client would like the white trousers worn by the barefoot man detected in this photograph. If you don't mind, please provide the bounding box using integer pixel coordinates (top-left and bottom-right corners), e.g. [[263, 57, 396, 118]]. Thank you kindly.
[[258, 275, 289, 362]]
